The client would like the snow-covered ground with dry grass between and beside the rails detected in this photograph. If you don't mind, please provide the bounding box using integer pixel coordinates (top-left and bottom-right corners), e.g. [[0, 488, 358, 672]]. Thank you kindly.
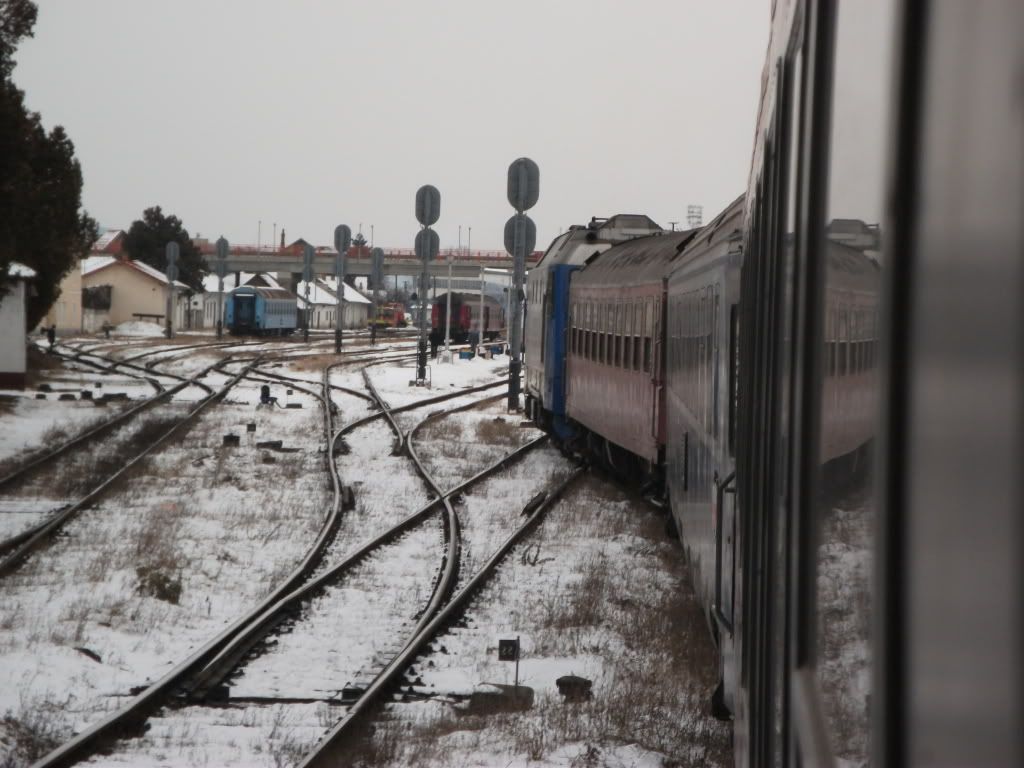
[[0, 340, 728, 768]]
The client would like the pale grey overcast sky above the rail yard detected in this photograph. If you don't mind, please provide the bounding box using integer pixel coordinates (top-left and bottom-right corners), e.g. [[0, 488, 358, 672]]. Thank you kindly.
[[14, 0, 769, 248]]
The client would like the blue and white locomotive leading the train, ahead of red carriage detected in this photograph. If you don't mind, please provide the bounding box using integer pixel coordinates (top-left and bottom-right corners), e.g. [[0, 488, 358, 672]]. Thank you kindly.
[[524, 214, 664, 437]]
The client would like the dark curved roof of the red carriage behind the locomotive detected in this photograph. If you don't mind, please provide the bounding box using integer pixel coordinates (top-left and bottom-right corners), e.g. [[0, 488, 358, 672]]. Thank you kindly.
[[572, 229, 700, 286]]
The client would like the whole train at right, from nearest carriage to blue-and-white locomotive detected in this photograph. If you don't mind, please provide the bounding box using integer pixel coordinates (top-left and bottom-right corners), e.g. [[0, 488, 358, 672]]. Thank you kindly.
[[526, 0, 1024, 766]]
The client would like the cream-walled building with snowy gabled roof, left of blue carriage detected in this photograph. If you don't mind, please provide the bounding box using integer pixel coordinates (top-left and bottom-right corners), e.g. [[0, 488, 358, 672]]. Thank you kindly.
[[82, 256, 191, 332]]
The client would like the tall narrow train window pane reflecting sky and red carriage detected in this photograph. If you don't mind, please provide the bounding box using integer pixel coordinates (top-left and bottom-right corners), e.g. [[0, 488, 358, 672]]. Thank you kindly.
[[811, 0, 892, 765]]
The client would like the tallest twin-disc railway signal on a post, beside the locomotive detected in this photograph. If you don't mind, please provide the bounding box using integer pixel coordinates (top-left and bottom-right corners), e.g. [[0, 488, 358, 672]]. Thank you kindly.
[[505, 158, 541, 412]]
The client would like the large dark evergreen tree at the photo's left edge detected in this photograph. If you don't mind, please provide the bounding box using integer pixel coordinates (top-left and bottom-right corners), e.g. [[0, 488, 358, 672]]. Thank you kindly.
[[0, 0, 96, 328]]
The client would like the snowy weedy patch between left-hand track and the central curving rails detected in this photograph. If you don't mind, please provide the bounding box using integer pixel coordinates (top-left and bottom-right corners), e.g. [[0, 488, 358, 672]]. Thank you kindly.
[[0, 370, 328, 759]]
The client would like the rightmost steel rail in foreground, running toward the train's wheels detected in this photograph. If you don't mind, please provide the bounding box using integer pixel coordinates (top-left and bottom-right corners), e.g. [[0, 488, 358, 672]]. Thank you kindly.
[[298, 467, 586, 768]]
